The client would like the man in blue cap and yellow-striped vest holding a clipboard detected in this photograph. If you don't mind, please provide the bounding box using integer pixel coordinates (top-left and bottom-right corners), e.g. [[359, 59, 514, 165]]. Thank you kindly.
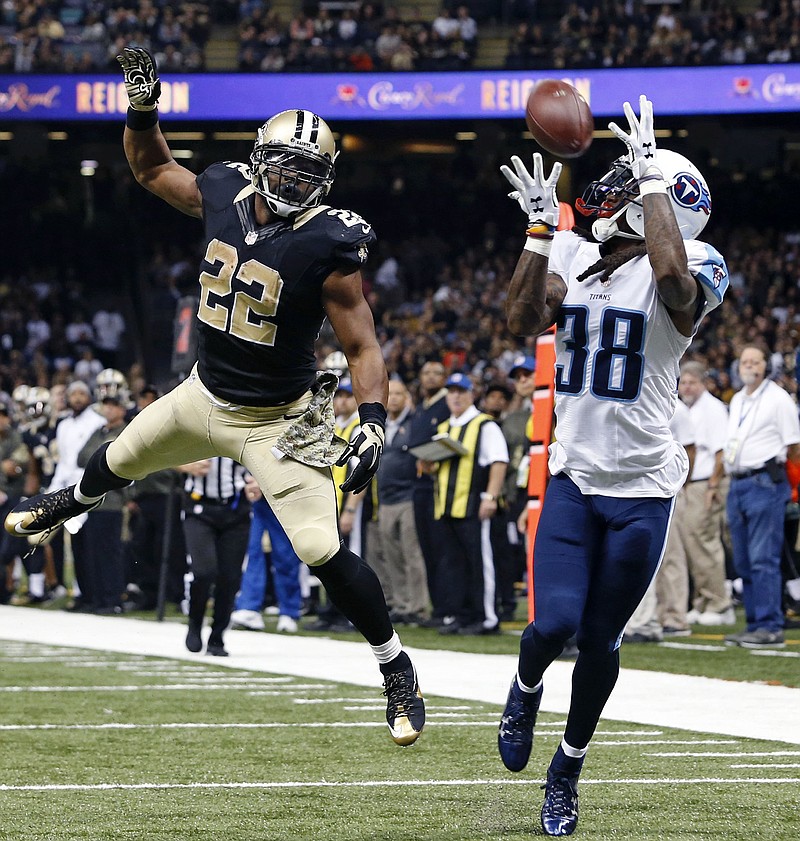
[[424, 373, 508, 635]]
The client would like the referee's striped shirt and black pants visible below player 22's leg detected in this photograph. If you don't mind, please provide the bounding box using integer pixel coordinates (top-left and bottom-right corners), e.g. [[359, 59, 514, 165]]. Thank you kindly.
[[179, 456, 250, 657]]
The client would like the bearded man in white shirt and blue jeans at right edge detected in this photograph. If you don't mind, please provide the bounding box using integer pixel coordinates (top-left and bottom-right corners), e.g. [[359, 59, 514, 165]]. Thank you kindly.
[[725, 345, 800, 648]]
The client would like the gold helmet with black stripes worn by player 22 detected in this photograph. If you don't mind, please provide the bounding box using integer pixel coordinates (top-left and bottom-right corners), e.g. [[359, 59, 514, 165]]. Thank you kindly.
[[250, 111, 338, 216]]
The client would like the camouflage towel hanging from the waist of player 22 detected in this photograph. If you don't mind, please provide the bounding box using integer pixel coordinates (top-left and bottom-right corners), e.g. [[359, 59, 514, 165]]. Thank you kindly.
[[272, 371, 347, 467]]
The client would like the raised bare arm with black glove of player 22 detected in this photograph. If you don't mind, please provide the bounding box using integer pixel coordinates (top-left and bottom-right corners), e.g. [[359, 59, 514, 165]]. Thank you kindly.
[[117, 47, 203, 217]]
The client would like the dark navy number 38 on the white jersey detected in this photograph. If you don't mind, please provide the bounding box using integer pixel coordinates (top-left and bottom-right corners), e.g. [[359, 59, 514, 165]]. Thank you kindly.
[[556, 306, 645, 403]]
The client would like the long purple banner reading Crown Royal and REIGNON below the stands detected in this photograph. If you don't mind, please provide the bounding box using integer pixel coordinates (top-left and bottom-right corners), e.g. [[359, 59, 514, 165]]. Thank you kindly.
[[0, 64, 800, 123]]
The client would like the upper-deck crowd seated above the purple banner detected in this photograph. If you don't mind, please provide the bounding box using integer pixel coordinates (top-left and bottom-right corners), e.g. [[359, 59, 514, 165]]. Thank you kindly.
[[0, 0, 800, 73]]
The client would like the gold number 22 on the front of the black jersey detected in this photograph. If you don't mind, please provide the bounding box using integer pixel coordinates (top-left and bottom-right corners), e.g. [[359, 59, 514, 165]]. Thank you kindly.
[[197, 239, 283, 346]]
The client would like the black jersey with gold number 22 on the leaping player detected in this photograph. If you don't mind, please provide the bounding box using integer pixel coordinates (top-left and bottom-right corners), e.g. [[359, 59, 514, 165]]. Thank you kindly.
[[197, 162, 375, 406]]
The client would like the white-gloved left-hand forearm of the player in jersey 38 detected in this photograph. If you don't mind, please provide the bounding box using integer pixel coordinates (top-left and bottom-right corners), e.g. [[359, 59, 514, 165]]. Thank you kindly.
[[500, 152, 567, 336]]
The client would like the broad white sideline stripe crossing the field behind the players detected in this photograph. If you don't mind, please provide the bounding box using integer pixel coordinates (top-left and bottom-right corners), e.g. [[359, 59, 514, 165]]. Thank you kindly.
[[0, 606, 800, 745]]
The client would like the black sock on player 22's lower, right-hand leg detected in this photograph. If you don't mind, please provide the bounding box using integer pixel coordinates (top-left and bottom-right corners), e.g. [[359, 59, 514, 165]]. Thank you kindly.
[[312, 545, 397, 644]]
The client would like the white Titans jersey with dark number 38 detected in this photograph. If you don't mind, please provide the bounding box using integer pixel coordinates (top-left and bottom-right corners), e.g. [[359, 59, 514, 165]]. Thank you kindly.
[[548, 231, 728, 497]]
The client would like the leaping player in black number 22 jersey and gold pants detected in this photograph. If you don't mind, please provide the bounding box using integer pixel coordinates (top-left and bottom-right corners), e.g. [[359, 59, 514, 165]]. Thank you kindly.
[[6, 48, 425, 745]]
